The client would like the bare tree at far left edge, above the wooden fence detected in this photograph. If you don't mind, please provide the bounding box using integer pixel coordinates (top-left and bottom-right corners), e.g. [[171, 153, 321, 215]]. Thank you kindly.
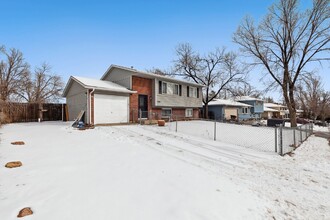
[[0, 46, 29, 102]]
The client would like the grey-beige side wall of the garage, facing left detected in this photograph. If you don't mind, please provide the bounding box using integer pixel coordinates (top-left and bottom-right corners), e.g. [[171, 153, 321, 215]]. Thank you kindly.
[[66, 81, 89, 122]]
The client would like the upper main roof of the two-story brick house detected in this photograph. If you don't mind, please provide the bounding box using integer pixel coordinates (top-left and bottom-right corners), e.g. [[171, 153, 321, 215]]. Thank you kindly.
[[101, 65, 203, 87]]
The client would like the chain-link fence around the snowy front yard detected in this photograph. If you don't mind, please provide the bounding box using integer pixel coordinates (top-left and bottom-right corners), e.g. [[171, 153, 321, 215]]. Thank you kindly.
[[153, 116, 313, 155]]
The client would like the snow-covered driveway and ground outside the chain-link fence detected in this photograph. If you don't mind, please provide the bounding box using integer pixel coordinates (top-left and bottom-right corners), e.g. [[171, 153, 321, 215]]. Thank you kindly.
[[0, 122, 330, 220]]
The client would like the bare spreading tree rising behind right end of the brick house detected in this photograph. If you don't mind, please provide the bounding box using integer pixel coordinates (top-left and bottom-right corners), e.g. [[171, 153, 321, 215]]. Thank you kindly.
[[174, 43, 245, 118]]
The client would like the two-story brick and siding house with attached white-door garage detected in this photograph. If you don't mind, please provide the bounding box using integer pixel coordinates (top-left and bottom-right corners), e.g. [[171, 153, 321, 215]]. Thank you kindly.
[[63, 65, 202, 124]]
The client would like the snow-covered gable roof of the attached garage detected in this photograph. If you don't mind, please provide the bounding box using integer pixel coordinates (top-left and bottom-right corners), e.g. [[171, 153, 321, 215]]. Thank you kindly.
[[62, 76, 136, 97]]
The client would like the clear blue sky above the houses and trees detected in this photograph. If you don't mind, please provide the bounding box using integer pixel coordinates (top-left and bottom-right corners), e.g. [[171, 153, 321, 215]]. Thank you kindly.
[[0, 0, 330, 99]]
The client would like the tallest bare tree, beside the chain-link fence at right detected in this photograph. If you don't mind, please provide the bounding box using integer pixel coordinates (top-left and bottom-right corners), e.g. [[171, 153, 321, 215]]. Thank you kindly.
[[234, 0, 330, 127]]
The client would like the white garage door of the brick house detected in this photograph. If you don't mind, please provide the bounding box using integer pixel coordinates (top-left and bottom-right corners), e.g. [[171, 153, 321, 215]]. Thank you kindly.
[[94, 94, 129, 124]]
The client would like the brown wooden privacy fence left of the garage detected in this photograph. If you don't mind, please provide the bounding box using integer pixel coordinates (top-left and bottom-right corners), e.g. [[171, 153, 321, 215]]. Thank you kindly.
[[0, 102, 66, 123]]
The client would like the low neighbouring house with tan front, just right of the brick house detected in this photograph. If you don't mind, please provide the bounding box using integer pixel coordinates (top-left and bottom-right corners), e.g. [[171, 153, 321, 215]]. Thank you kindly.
[[208, 99, 252, 121]]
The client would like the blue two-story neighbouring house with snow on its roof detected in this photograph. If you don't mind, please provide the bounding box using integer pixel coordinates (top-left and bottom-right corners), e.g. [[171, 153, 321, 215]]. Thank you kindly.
[[235, 96, 264, 120]]
